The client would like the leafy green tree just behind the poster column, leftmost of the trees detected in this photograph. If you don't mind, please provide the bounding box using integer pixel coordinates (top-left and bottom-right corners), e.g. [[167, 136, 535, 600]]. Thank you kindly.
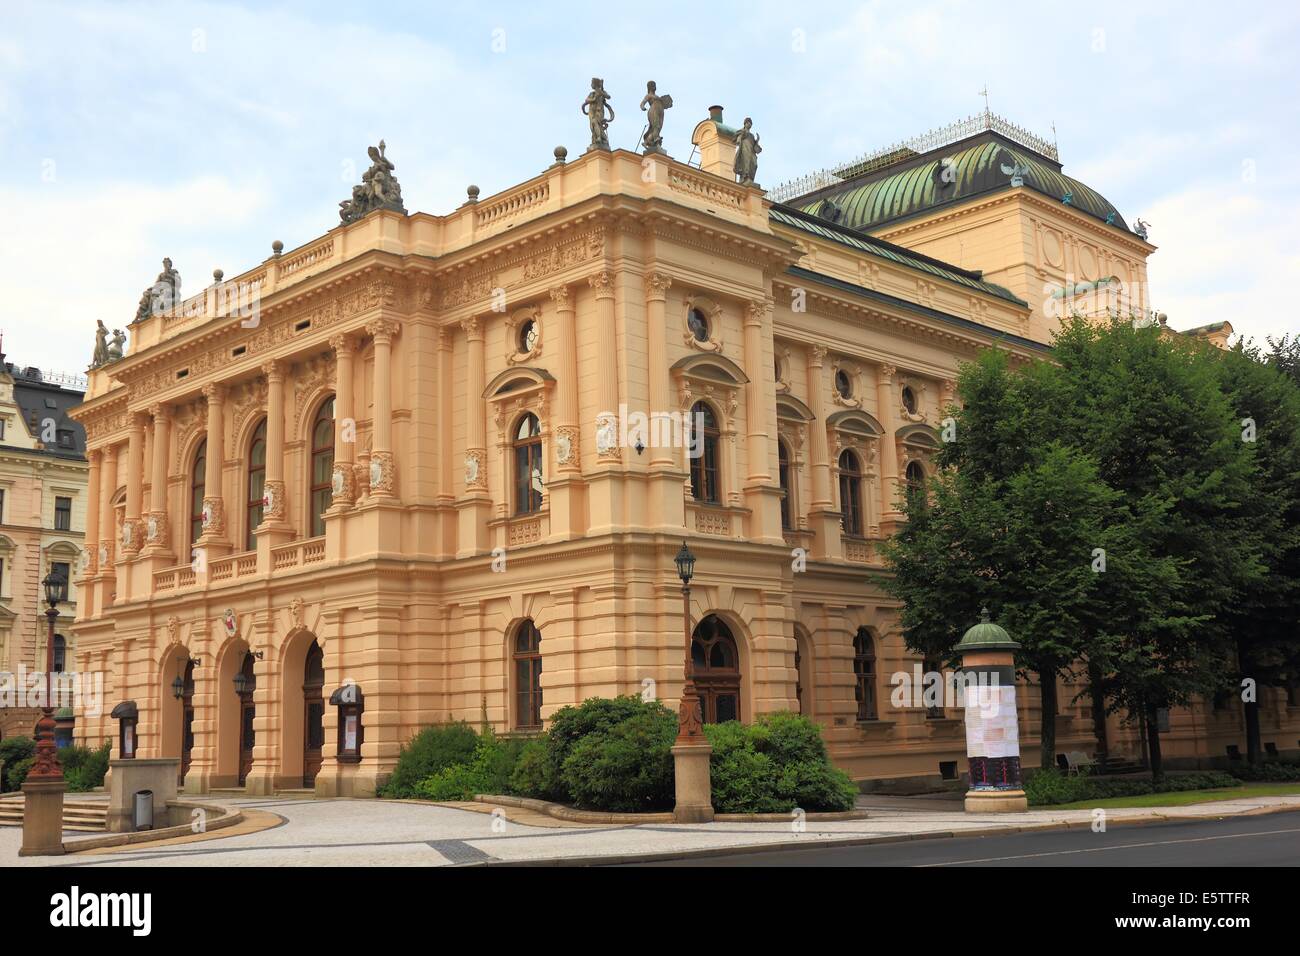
[[881, 352, 1127, 766]]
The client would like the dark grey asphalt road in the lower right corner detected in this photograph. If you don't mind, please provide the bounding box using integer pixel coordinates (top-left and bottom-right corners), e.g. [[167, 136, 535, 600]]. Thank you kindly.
[[621, 813, 1300, 866]]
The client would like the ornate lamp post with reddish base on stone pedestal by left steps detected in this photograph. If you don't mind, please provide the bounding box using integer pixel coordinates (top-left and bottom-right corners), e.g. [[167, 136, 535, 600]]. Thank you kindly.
[[18, 571, 68, 856]]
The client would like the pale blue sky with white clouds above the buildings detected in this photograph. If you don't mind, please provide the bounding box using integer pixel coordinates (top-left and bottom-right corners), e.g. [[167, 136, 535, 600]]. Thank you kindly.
[[0, 0, 1300, 373]]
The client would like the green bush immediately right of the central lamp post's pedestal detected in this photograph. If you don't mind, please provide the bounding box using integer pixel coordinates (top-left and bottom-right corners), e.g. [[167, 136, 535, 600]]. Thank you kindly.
[[705, 713, 858, 813]]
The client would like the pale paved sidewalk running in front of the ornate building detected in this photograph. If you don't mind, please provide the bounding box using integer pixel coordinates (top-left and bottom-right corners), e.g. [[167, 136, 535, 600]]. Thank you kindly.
[[0, 795, 1300, 866]]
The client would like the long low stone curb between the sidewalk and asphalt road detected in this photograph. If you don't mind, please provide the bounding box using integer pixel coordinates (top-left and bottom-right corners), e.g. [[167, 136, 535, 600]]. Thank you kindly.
[[473, 804, 1300, 866]]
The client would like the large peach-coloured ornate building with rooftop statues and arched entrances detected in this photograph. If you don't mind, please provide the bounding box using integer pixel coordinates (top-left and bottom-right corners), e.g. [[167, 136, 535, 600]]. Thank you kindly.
[[68, 108, 1300, 793]]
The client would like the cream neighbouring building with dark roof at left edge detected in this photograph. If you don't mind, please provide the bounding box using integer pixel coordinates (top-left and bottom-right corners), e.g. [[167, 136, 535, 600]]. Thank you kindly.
[[0, 351, 87, 736]]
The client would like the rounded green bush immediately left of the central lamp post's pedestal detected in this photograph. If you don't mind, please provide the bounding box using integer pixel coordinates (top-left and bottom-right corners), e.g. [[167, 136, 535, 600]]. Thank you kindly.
[[560, 698, 677, 813]]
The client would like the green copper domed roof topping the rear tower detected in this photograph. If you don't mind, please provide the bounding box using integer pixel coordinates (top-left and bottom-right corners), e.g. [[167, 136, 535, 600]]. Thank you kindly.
[[792, 131, 1128, 232]]
